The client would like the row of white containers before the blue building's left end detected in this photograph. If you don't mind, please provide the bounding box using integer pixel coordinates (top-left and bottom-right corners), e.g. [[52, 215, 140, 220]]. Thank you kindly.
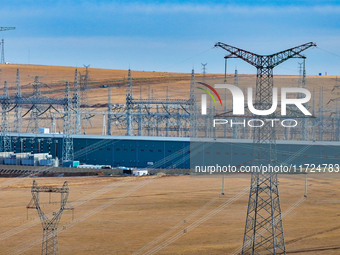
[[0, 152, 59, 167]]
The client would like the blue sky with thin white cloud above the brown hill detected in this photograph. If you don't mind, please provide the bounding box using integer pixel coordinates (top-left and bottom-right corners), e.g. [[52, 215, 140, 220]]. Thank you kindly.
[[0, 0, 340, 75]]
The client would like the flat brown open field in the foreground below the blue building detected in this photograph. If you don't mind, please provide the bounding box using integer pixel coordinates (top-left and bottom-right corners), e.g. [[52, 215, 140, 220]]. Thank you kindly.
[[0, 174, 340, 255]]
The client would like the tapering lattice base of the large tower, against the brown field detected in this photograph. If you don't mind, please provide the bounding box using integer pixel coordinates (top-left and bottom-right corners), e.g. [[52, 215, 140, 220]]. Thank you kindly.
[[242, 173, 286, 254]]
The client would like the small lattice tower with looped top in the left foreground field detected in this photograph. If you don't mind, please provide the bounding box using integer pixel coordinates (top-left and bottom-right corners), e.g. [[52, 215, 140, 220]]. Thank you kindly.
[[31, 180, 69, 255]]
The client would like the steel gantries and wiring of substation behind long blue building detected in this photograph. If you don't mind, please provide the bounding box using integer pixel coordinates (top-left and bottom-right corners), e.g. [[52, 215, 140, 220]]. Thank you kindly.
[[0, 54, 340, 166]]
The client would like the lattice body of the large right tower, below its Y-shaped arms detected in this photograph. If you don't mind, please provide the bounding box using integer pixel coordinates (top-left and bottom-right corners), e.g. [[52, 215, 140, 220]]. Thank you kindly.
[[242, 68, 286, 254]]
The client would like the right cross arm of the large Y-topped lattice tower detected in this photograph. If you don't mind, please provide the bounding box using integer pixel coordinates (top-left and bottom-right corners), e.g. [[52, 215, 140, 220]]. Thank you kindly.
[[268, 42, 316, 67]]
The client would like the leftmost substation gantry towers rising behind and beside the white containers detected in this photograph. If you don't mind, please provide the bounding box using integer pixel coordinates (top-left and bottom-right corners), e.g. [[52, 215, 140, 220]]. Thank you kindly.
[[0, 69, 81, 162]]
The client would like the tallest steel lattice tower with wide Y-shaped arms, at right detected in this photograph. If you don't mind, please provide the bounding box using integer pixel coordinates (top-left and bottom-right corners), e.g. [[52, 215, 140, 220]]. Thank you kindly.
[[215, 42, 316, 254]]
